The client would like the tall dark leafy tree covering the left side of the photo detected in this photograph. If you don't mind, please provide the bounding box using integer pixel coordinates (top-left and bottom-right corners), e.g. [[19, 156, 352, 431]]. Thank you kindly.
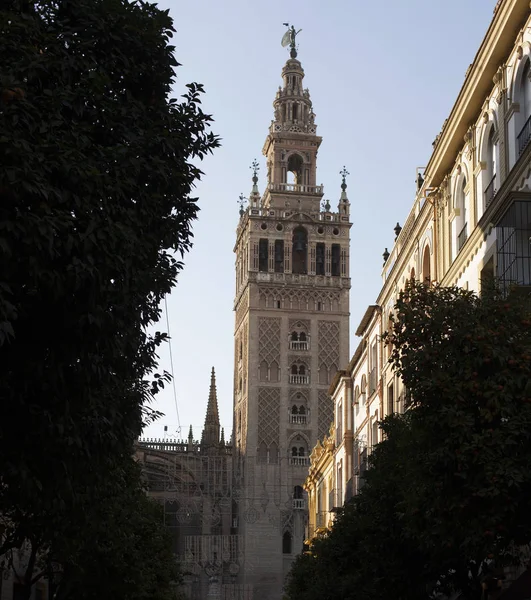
[[0, 0, 218, 596]]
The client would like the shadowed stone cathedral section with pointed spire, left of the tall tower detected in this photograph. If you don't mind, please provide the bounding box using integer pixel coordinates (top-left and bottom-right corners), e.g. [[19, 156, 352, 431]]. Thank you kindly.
[[135, 369, 238, 600]]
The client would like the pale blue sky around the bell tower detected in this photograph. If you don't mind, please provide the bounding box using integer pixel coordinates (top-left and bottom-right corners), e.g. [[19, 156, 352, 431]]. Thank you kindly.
[[144, 0, 496, 439]]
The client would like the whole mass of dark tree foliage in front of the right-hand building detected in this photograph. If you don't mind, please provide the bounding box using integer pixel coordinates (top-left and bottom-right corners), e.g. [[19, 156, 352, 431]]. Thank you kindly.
[[288, 283, 531, 600]]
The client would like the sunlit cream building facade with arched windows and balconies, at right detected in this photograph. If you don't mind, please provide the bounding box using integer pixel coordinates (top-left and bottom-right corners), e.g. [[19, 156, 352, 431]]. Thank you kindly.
[[305, 0, 531, 535]]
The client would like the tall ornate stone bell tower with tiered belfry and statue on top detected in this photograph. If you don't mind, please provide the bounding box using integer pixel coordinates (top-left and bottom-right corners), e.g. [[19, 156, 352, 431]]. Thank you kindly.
[[233, 36, 351, 600]]
